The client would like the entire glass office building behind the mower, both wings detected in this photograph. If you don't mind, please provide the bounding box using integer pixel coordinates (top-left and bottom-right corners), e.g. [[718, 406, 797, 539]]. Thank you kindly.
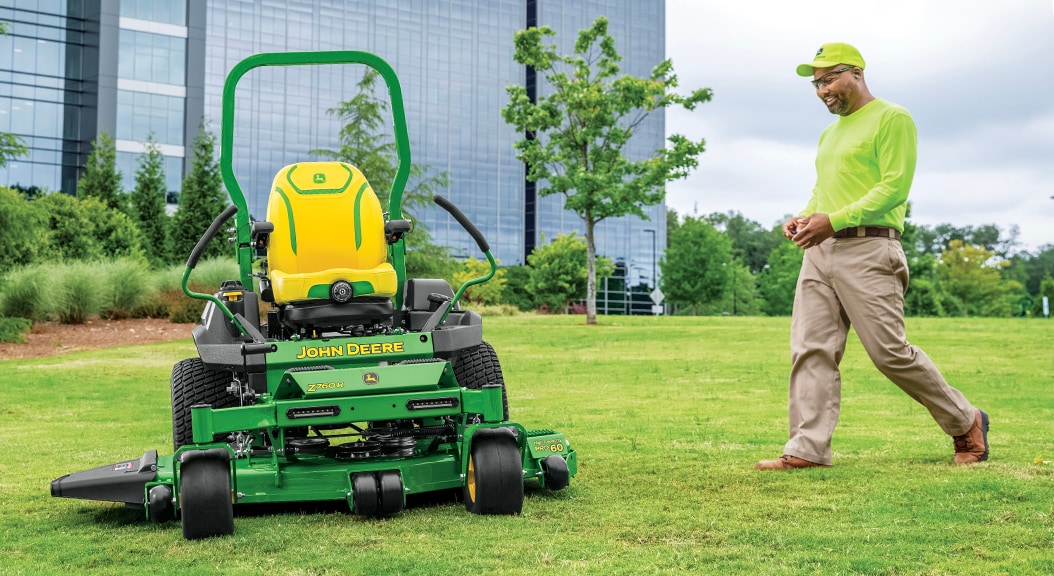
[[0, 0, 666, 284]]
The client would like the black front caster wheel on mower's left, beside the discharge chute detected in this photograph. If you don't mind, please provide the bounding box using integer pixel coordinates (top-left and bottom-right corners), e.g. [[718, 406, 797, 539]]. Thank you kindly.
[[179, 458, 234, 540]]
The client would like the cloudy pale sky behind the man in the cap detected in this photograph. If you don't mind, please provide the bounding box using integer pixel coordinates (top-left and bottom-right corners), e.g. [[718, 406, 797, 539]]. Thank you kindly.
[[666, 0, 1054, 252]]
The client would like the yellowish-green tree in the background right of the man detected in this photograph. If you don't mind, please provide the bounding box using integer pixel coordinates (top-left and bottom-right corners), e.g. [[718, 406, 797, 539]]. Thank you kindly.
[[937, 239, 1014, 316]]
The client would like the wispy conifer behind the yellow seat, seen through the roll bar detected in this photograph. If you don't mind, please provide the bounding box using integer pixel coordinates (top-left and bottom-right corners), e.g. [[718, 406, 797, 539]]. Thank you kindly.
[[309, 70, 458, 280]]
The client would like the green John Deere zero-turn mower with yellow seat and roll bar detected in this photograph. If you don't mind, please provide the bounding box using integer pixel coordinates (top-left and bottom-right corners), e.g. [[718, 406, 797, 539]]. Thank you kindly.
[[51, 51, 577, 538]]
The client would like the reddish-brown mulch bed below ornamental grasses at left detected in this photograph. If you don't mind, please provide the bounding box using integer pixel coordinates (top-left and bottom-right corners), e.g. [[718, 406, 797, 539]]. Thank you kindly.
[[0, 319, 195, 360]]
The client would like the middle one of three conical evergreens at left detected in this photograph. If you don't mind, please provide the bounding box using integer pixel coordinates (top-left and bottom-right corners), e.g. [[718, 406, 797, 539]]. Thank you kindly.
[[131, 136, 169, 268]]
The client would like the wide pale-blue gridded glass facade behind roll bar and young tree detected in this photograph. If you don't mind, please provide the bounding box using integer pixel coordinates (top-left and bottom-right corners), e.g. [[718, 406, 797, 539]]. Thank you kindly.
[[204, 0, 665, 269]]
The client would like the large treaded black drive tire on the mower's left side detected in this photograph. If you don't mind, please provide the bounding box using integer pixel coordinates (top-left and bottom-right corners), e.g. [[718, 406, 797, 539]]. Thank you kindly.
[[171, 358, 238, 450]]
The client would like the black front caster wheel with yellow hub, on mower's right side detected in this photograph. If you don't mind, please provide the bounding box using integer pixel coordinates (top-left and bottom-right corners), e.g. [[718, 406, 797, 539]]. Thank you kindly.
[[463, 430, 524, 515]]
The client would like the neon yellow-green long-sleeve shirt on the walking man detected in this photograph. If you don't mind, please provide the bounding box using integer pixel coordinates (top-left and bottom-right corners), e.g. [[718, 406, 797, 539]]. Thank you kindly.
[[799, 98, 918, 232]]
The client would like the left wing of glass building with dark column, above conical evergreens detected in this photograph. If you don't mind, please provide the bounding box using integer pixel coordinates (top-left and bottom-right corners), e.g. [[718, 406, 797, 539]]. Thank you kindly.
[[0, 0, 204, 194]]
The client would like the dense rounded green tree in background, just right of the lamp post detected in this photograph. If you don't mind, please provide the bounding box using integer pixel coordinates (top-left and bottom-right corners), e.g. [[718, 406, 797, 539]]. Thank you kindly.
[[659, 216, 731, 314]]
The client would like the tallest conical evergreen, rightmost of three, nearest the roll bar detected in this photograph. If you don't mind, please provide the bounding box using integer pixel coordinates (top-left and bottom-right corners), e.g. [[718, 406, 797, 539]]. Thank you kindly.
[[169, 121, 232, 262]]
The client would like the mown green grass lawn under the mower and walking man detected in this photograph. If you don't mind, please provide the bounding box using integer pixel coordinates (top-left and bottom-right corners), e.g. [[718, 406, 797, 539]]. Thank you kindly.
[[0, 315, 1054, 575]]
